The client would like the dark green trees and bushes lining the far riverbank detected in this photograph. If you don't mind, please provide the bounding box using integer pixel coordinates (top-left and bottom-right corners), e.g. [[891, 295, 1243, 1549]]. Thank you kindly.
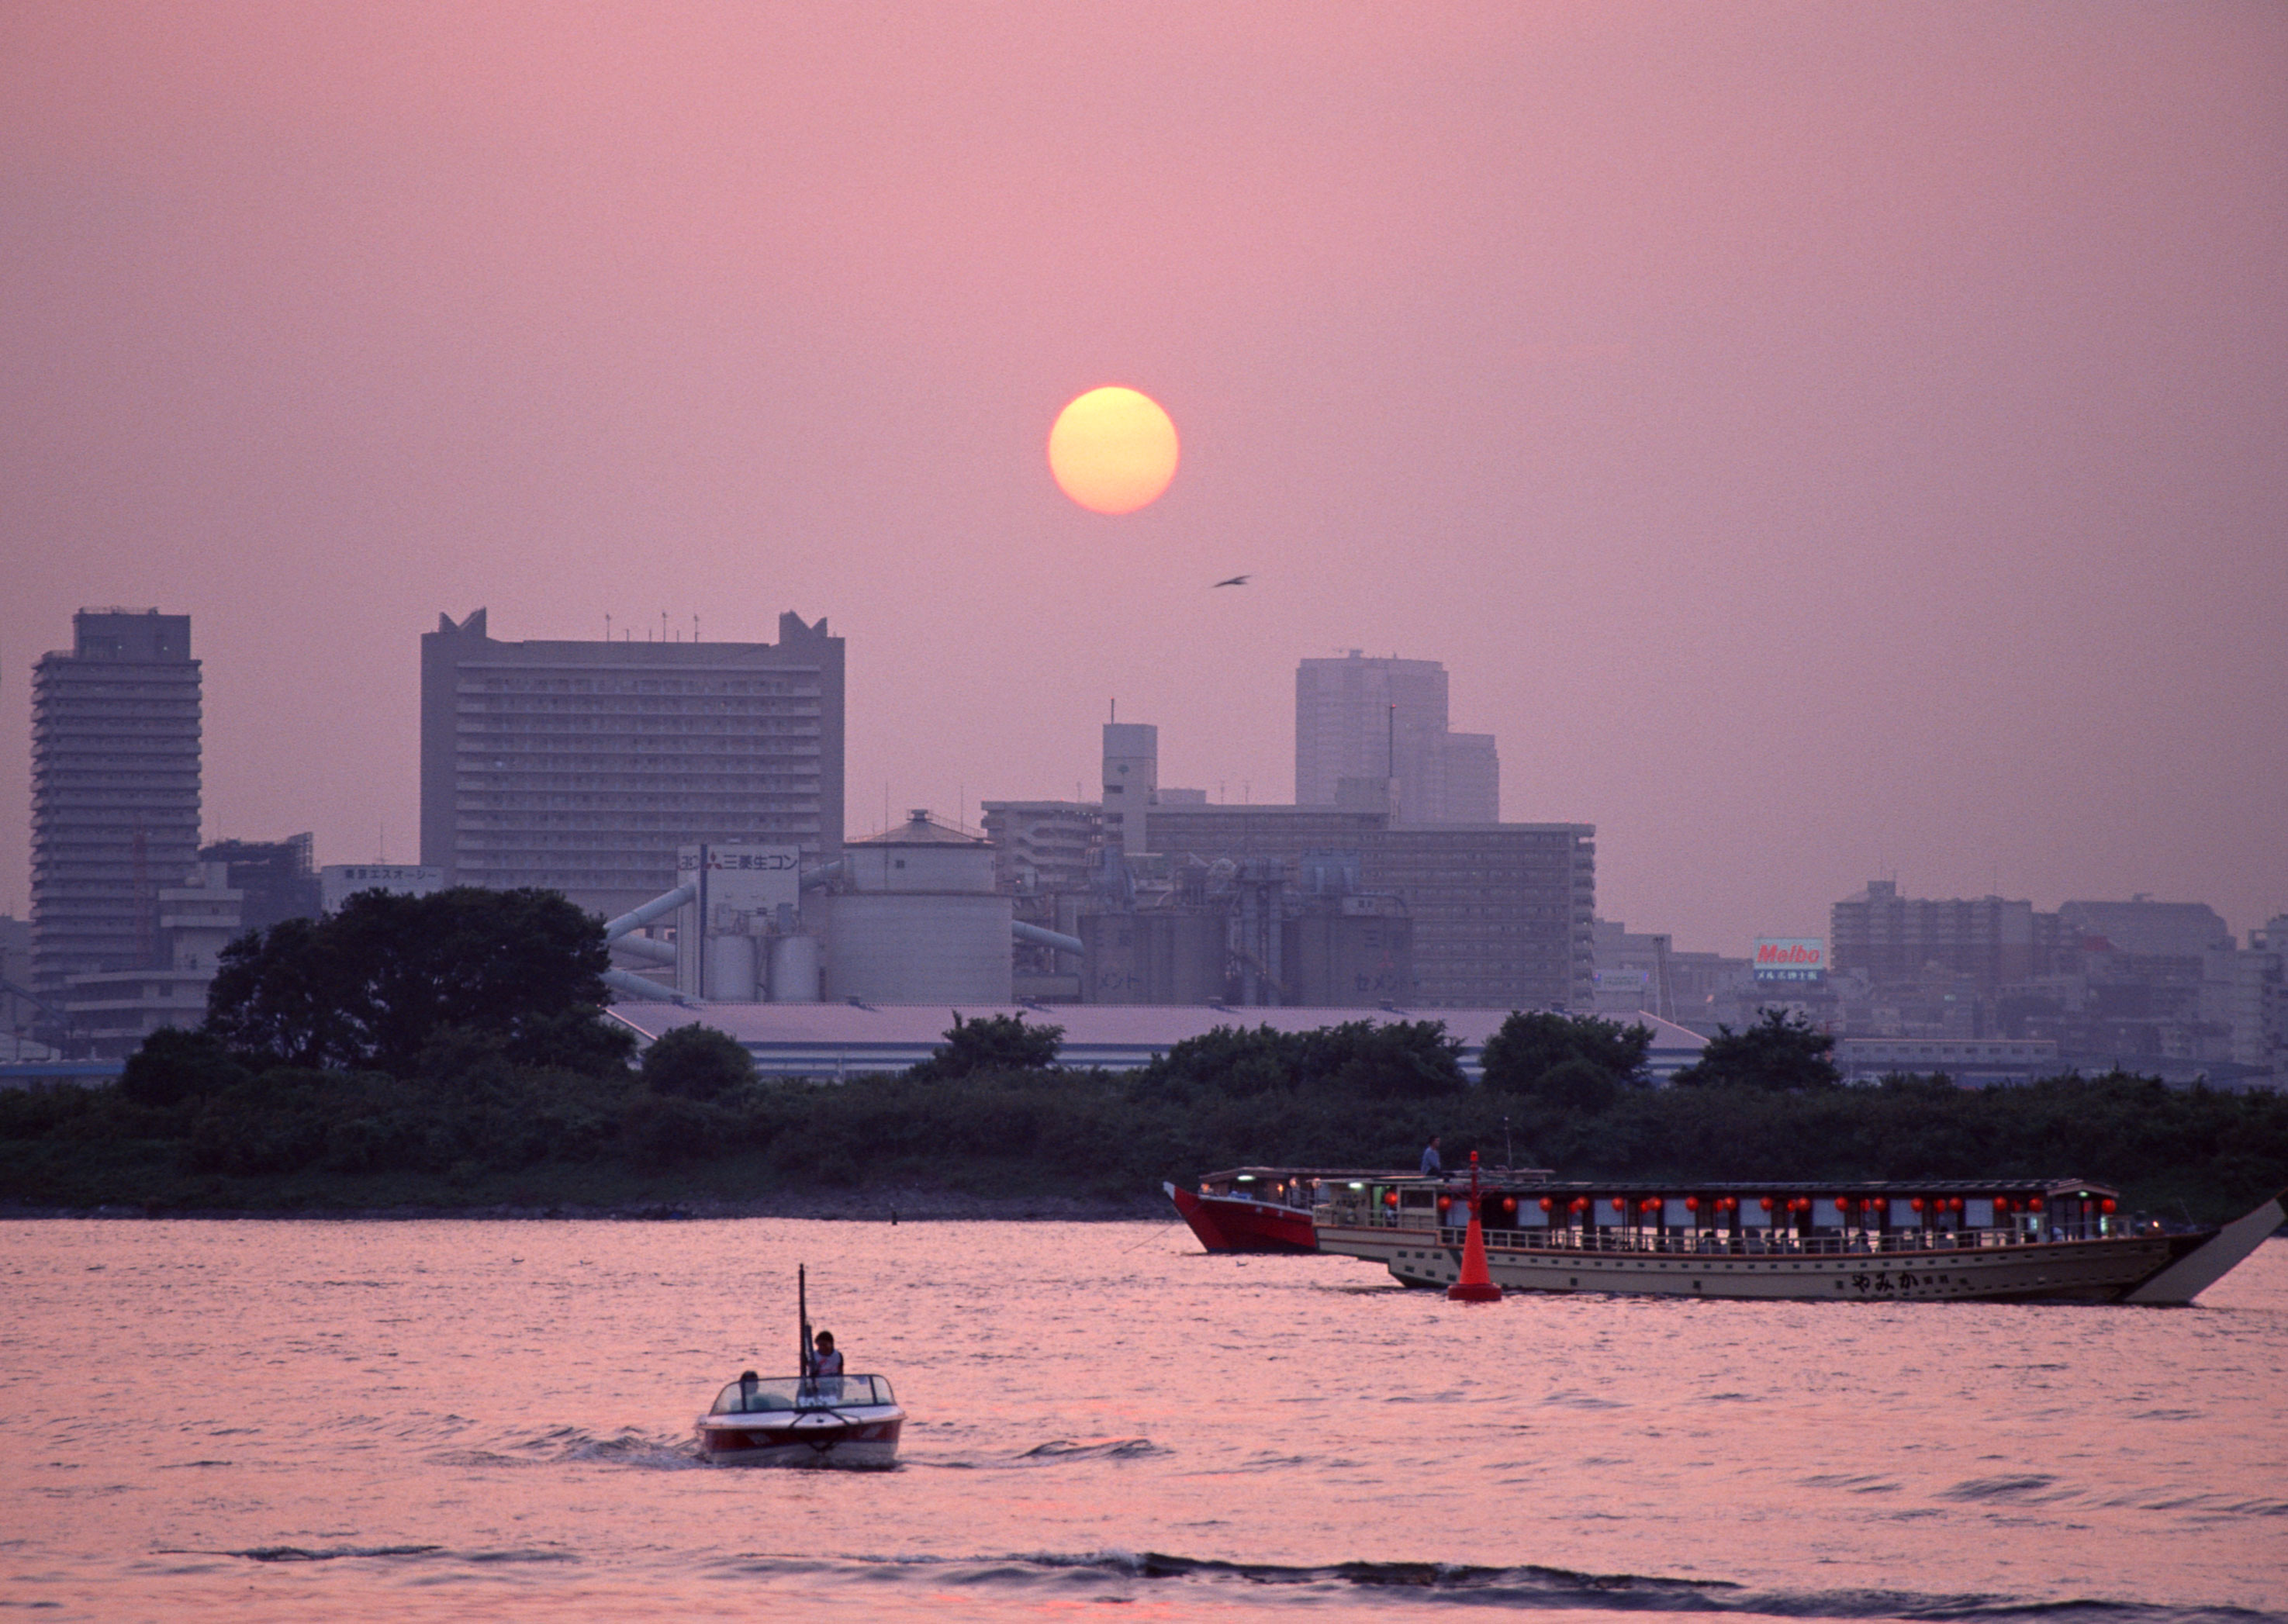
[[0, 928, 2288, 1217]]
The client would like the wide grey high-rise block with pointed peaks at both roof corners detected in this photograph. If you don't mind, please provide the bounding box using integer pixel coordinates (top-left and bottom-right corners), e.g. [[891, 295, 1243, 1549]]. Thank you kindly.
[[421, 609, 842, 915]]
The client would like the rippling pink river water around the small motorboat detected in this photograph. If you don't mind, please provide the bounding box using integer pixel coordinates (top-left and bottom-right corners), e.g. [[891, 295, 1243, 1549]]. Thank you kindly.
[[0, 1219, 2288, 1622]]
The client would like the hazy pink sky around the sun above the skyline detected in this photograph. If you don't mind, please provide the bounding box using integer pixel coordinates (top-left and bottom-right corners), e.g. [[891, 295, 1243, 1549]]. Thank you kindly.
[[0, 0, 2288, 952]]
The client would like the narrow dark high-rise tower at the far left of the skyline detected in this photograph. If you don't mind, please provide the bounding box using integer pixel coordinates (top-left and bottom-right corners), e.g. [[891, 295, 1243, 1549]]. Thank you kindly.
[[32, 609, 199, 1000]]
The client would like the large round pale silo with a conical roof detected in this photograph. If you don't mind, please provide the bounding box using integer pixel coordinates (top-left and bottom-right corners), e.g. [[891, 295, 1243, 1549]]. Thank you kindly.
[[803, 812, 1011, 1004]]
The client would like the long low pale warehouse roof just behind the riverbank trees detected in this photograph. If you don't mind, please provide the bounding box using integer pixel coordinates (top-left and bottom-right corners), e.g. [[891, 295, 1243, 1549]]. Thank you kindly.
[[611, 1004, 1707, 1082]]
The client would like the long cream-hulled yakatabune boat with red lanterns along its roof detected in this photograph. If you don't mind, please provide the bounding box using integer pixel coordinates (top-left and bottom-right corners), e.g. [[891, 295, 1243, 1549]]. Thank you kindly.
[[1311, 1173, 2288, 1304]]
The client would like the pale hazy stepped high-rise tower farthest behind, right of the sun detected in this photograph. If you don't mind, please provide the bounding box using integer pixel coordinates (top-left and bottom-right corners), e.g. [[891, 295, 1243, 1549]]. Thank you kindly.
[[1295, 650, 1501, 826]]
